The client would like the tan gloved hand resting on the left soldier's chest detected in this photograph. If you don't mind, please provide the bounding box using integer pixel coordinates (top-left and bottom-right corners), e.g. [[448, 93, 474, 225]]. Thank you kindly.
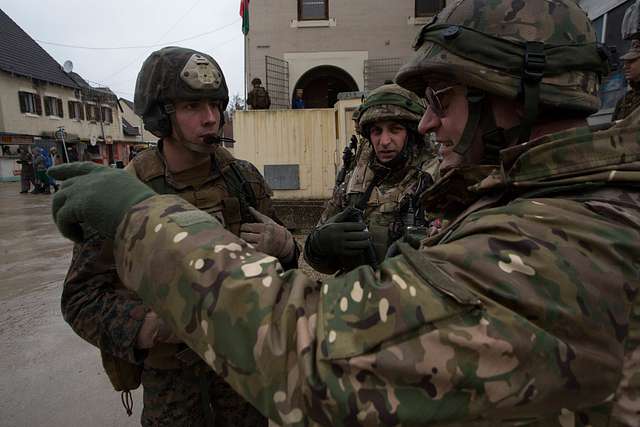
[[240, 207, 296, 262]]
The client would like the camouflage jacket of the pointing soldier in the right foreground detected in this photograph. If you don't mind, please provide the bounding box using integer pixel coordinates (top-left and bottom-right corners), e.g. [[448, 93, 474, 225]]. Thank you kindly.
[[115, 112, 640, 427]]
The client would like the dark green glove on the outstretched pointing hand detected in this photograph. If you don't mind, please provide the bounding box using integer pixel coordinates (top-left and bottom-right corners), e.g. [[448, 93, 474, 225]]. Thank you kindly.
[[48, 162, 156, 242]]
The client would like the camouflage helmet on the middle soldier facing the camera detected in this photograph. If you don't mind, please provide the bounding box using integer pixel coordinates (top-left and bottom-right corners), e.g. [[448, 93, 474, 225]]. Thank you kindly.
[[353, 84, 425, 138]]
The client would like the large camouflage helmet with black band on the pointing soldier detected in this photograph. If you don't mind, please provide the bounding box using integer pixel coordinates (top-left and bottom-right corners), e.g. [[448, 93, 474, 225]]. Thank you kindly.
[[396, 0, 608, 152]]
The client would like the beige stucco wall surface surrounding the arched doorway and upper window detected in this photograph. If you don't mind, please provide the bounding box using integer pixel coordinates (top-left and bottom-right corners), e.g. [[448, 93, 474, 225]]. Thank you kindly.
[[246, 0, 440, 96]]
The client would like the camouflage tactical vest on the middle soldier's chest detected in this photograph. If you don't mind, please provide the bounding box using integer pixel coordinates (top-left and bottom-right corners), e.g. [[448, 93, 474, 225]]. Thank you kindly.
[[345, 144, 438, 260]]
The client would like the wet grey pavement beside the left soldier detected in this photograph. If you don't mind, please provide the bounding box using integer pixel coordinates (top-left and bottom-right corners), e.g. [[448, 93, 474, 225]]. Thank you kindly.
[[0, 183, 142, 427]]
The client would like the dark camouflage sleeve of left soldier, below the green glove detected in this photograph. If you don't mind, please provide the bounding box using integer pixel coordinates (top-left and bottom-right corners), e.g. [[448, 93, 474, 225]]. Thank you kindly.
[[61, 229, 146, 363]]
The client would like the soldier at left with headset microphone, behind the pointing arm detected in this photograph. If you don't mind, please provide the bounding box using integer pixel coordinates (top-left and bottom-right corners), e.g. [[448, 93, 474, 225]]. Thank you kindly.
[[62, 48, 298, 426]]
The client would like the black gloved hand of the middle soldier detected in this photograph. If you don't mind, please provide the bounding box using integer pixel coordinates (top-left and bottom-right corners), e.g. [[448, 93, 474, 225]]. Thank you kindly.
[[313, 222, 370, 257]]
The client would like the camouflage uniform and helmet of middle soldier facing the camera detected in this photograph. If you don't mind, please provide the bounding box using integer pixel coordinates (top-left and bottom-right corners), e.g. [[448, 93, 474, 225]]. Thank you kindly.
[[304, 84, 438, 274]]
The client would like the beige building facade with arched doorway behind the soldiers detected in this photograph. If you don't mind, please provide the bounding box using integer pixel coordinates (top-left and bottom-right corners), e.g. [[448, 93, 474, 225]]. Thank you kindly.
[[245, 0, 445, 109]]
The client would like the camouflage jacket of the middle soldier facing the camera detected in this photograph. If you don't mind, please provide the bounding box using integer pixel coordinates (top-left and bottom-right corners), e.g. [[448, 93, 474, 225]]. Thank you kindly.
[[304, 141, 438, 273]]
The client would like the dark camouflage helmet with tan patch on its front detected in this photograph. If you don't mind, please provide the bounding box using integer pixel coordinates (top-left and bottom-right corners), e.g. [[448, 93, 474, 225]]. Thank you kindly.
[[134, 46, 229, 138]]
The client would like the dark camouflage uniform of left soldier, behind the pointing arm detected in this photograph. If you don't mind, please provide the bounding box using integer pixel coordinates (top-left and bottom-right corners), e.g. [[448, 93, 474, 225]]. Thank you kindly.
[[62, 143, 297, 426]]
